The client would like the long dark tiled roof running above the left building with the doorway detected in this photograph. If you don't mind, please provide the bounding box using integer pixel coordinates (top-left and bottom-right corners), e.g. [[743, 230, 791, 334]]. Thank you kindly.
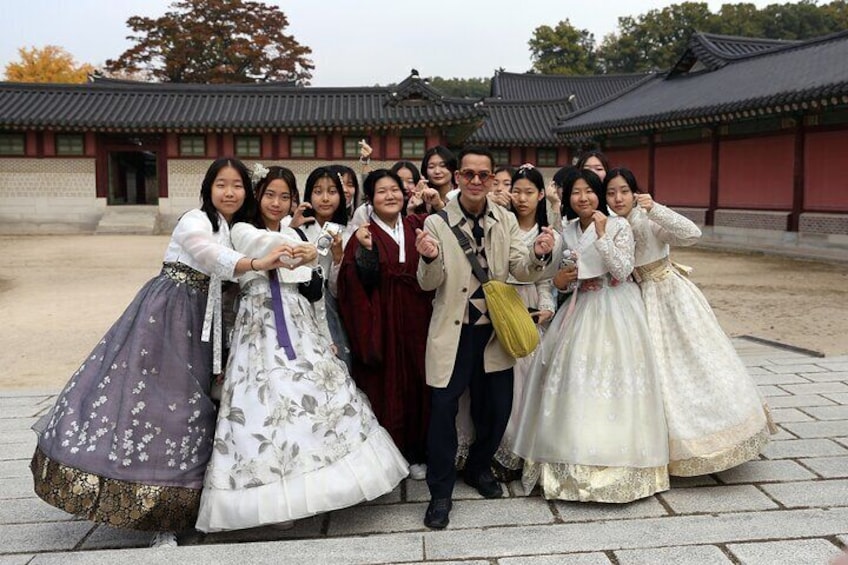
[[0, 75, 485, 132]]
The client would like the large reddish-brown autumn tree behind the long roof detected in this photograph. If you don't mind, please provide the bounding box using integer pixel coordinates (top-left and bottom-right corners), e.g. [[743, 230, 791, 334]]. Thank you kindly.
[[106, 0, 315, 84]]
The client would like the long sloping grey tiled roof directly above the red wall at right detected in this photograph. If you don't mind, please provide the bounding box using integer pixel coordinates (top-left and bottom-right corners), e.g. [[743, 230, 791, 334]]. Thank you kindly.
[[556, 31, 848, 138]]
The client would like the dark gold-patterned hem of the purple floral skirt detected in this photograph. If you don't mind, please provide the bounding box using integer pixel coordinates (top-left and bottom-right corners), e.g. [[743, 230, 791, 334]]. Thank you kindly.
[[30, 448, 200, 532]]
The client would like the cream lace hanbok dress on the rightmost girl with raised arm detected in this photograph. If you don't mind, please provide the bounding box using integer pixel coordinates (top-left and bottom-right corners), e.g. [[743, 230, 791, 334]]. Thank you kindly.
[[627, 203, 770, 476]]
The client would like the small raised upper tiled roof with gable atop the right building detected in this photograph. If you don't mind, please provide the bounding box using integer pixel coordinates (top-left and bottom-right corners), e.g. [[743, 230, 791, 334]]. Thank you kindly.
[[671, 32, 799, 75]]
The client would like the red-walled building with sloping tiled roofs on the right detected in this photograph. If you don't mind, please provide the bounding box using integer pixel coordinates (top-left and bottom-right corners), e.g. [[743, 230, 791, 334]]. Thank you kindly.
[[555, 31, 848, 259]]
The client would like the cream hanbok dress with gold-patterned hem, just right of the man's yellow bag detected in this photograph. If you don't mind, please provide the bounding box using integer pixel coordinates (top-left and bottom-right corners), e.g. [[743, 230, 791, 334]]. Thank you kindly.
[[514, 218, 668, 503]]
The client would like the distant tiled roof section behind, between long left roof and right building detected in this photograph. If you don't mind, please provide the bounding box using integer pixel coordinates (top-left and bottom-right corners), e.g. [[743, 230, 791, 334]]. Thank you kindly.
[[492, 71, 646, 104]]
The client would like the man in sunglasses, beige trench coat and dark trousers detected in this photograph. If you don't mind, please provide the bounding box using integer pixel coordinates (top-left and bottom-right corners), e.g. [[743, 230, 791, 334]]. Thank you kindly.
[[416, 147, 561, 529]]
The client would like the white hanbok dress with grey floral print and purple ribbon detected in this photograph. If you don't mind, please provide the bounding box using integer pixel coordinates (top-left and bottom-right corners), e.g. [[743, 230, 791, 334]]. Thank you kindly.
[[197, 223, 409, 532]]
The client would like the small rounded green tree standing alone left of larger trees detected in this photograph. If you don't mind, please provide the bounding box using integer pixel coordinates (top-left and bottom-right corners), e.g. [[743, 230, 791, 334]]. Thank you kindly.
[[527, 19, 597, 75]]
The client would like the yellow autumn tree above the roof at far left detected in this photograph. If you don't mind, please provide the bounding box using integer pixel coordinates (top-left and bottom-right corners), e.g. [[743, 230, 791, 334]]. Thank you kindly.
[[6, 45, 94, 83]]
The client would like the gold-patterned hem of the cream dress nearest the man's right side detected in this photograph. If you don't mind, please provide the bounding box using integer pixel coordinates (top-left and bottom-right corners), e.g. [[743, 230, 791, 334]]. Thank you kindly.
[[522, 463, 669, 504]]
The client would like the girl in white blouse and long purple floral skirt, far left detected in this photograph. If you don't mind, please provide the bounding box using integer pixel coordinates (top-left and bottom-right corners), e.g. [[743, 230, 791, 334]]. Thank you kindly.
[[31, 159, 290, 547]]
